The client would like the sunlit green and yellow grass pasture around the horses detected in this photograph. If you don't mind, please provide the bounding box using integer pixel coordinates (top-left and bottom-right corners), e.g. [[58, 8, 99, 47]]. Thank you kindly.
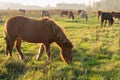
[[0, 10, 120, 80]]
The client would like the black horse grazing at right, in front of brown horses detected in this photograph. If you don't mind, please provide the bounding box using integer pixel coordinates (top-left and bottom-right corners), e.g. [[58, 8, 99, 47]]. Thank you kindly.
[[101, 12, 114, 27]]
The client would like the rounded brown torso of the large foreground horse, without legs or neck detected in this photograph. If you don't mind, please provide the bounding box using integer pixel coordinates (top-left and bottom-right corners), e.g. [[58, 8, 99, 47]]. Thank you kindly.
[[5, 16, 53, 43]]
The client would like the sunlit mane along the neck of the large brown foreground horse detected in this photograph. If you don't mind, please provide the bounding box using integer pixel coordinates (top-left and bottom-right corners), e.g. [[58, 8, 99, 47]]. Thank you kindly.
[[42, 18, 73, 48]]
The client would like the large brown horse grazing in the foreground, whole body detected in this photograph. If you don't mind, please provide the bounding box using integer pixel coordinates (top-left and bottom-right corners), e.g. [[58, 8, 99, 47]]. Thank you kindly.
[[4, 16, 73, 64]]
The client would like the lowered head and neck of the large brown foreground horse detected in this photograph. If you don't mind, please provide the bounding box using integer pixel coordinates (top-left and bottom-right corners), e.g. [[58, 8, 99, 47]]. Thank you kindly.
[[52, 20, 73, 64]]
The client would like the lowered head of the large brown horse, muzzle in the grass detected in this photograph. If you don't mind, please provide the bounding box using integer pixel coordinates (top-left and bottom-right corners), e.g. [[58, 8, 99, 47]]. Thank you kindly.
[[61, 39, 73, 64]]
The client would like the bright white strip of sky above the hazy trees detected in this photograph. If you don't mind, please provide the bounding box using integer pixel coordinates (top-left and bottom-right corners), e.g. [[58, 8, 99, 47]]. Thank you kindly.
[[0, 0, 100, 7]]
